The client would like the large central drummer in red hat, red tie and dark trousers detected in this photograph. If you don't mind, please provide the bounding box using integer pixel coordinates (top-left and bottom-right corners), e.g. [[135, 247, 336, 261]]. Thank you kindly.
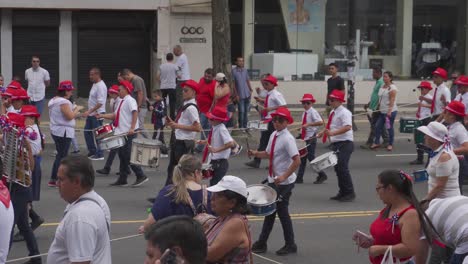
[[249, 107, 301, 255]]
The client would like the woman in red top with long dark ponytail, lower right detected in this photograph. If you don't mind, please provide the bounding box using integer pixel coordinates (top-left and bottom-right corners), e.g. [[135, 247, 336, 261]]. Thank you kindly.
[[353, 170, 432, 264]]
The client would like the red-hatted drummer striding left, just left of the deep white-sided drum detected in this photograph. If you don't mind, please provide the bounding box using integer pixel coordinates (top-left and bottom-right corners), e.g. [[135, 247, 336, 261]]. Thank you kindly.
[[96, 81, 148, 187]]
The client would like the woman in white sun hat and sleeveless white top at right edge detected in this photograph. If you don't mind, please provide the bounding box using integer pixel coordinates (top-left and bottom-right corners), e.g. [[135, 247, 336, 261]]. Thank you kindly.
[[418, 122, 460, 203]]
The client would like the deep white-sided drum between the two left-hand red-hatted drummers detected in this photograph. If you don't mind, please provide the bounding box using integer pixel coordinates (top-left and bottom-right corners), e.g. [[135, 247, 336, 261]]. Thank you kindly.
[[130, 138, 162, 168]]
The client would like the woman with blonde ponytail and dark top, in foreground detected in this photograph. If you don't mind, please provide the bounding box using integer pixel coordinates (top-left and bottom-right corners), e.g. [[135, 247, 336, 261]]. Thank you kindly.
[[139, 154, 211, 233]]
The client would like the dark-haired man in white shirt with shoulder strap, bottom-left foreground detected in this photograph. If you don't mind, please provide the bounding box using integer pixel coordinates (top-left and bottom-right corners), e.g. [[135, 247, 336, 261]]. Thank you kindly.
[[47, 155, 112, 264]]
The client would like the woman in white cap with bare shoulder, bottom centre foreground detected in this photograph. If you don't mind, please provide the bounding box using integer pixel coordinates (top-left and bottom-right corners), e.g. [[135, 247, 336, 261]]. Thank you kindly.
[[206, 175, 252, 263]]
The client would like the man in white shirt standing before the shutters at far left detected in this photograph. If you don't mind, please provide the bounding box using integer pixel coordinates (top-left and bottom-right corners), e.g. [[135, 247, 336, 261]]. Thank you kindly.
[[24, 56, 50, 115]]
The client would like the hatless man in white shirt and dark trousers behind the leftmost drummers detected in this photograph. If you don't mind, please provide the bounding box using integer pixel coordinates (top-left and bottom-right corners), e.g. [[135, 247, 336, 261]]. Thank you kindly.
[[83, 67, 107, 160]]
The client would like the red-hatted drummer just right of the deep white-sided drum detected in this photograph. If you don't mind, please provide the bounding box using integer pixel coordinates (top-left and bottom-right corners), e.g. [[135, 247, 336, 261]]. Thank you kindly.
[[166, 80, 201, 186]]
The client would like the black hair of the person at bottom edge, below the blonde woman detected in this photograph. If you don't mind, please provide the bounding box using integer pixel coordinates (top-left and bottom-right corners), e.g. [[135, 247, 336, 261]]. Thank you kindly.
[[145, 215, 208, 264]]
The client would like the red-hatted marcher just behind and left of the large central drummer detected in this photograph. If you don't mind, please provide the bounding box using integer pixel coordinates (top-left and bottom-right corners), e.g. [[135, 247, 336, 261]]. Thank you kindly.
[[245, 74, 286, 168]]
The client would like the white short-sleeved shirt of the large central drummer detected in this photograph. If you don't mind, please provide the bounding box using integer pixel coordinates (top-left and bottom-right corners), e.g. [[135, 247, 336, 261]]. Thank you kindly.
[[265, 128, 299, 185]]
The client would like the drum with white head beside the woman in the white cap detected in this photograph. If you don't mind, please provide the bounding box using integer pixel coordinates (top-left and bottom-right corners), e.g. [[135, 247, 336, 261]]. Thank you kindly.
[[247, 184, 278, 216]]
